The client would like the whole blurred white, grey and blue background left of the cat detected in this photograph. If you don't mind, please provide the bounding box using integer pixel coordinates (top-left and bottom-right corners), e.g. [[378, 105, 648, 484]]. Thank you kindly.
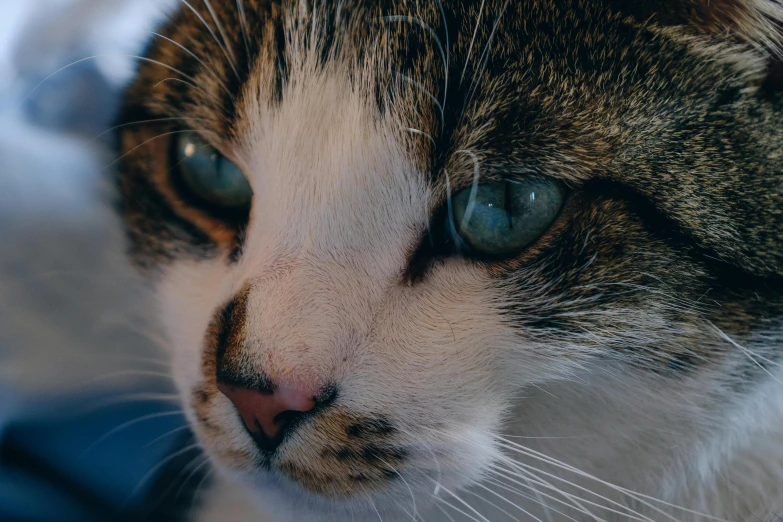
[[0, 0, 209, 522]]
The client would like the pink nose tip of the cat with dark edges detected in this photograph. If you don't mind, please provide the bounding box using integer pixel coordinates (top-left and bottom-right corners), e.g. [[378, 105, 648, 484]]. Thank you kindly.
[[218, 381, 316, 440]]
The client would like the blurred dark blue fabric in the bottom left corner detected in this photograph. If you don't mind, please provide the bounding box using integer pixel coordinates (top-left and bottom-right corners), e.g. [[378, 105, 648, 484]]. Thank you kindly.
[[0, 389, 205, 522]]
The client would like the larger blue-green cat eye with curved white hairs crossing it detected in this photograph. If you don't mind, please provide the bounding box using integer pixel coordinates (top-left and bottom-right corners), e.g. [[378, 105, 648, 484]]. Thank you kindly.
[[452, 178, 563, 256]]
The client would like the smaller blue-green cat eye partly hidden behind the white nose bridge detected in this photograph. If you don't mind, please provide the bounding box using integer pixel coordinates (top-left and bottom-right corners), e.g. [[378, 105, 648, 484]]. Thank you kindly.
[[177, 132, 253, 208]]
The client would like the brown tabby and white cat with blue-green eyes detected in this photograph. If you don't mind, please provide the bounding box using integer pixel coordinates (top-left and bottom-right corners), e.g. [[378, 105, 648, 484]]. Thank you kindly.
[[117, 0, 783, 522]]
